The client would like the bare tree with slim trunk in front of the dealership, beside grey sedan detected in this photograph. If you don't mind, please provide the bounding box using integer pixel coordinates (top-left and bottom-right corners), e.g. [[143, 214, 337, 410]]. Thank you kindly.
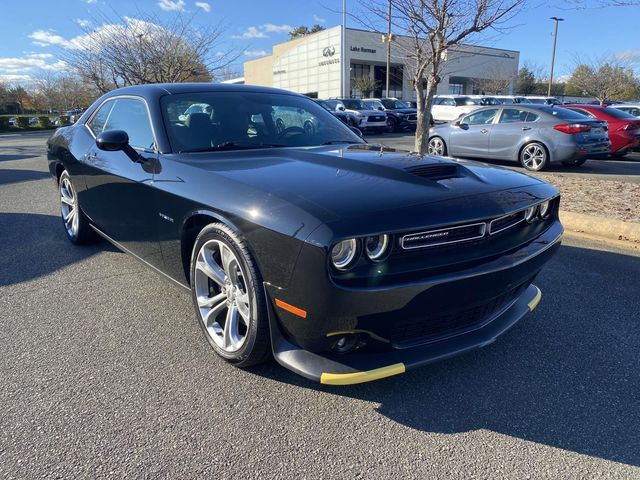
[[367, 0, 526, 154]]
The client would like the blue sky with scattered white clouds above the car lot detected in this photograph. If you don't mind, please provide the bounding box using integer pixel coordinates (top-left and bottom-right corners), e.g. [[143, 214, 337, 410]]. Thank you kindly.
[[0, 0, 640, 80]]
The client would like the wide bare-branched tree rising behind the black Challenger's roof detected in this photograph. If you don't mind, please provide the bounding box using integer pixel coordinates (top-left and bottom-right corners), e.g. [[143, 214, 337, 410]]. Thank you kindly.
[[63, 14, 239, 92]]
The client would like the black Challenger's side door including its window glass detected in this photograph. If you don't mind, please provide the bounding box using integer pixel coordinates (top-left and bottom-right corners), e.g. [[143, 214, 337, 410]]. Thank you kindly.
[[83, 96, 162, 267]]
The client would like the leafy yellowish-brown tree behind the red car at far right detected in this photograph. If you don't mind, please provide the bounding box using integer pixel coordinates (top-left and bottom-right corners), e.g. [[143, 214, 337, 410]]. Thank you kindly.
[[567, 58, 640, 104]]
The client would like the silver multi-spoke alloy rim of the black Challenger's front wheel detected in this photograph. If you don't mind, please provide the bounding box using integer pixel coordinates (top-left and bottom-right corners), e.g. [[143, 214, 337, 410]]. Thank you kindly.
[[194, 240, 251, 353]]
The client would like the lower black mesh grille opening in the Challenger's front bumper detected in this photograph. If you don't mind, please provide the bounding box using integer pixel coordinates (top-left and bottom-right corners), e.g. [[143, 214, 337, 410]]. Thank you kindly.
[[390, 280, 531, 348]]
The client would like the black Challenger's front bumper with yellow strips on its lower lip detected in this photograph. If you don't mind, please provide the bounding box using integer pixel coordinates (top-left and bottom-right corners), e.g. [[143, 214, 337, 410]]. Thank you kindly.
[[265, 221, 563, 384]]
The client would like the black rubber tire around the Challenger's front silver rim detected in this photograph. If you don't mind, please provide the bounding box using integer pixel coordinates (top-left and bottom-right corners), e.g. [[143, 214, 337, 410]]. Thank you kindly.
[[190, 223, 271, 368]]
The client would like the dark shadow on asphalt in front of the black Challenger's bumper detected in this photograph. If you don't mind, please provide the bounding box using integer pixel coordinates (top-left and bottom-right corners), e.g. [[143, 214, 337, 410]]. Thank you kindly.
[[254, 246, 640, 465]]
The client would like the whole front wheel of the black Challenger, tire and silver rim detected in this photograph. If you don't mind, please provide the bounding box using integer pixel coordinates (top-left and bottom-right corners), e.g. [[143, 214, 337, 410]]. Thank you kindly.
[[191, 223, 270, 367]]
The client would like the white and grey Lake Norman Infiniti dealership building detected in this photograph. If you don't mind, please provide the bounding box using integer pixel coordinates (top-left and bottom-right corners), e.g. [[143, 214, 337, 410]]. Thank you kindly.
[[243, 26, 520, 100]]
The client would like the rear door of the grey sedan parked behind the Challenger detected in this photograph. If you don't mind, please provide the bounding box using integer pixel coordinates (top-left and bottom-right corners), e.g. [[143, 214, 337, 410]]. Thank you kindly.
[[488, 108, 538, 160]]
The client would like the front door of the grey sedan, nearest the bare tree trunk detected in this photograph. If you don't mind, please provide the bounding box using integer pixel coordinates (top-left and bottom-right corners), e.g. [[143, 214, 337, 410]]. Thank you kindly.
[[449, 108, 499, 157]]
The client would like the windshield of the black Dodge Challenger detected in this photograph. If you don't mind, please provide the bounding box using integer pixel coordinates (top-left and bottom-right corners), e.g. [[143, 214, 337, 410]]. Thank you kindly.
[[160, 92, 364, 153]]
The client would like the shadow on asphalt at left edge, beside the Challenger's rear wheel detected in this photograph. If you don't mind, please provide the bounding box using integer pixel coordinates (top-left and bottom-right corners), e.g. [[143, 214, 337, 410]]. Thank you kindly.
[[0, 213, 111, 286]]
